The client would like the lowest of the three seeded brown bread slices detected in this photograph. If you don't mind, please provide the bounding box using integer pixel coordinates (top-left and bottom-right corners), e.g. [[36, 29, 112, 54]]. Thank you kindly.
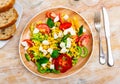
[[0, 24, 16, 40]]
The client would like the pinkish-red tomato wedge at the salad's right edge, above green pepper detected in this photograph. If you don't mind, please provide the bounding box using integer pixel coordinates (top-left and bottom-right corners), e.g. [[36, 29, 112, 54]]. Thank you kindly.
[[78, 34, 90, 46]]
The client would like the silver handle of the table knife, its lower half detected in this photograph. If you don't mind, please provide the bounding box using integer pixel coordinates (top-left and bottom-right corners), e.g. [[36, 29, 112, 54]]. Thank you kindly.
[[106, 38, 114, 67]]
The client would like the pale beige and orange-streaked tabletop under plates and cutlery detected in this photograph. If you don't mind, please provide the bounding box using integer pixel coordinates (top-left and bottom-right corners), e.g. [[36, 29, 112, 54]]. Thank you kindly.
[[0, 0, 120, 84]]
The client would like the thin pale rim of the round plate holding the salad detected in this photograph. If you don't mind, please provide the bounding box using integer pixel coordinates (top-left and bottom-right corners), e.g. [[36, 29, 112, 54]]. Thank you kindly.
[[19, 6, 94, 79]]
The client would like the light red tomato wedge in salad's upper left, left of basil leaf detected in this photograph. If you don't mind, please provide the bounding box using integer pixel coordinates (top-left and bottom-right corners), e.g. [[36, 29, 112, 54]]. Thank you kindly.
[[36, 24, 50, 34]]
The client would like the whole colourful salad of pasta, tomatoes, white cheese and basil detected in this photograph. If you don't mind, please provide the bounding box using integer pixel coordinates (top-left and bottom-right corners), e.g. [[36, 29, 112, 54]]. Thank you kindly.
[[21, 11, 90, 73]]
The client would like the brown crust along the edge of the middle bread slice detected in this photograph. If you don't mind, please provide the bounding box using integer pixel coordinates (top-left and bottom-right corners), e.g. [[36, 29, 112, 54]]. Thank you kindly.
[[0, 8, 18, 29]]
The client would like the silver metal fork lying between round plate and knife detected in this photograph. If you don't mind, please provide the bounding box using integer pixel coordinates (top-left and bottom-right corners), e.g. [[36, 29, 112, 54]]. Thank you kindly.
[[94, 11, 106, 64]]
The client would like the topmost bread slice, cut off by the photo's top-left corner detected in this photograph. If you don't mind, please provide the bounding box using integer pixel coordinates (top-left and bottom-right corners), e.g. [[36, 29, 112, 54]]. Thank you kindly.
[[0, 0, 15, 12]]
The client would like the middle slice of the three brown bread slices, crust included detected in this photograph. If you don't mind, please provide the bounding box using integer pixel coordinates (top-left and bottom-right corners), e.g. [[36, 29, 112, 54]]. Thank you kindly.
[[0, 8, 18, 29]]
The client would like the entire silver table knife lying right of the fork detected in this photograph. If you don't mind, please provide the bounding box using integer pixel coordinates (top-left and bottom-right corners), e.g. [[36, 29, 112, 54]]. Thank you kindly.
[[102, 7, 114, 66]]
